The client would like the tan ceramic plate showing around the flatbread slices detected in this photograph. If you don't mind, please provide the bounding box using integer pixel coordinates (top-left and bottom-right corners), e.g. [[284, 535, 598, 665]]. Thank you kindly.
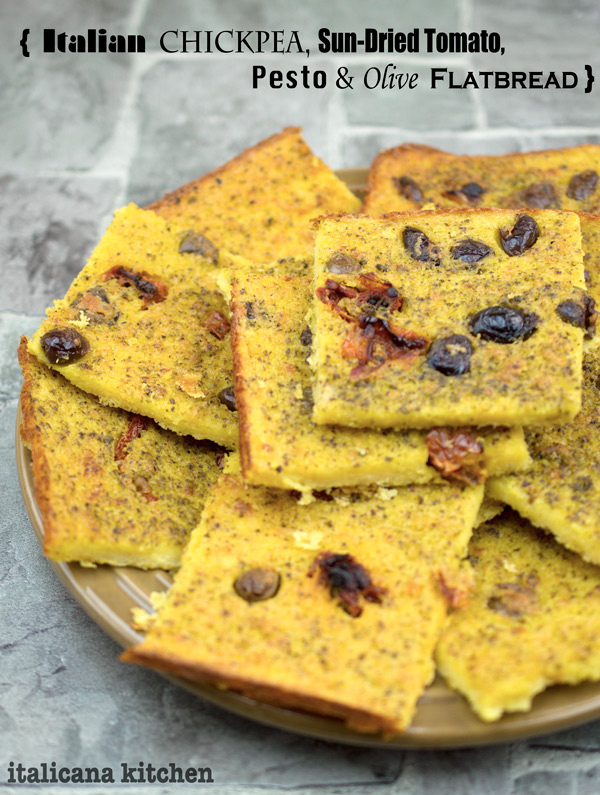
[[16, 169, 600, 748]]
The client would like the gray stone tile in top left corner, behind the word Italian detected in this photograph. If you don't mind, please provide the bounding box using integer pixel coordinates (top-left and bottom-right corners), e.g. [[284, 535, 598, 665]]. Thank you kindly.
[[0, 0, 132, 173]]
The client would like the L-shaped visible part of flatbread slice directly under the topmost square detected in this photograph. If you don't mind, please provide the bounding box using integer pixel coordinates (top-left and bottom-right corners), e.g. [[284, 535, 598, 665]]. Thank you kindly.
[[231, 257, 529, 490]]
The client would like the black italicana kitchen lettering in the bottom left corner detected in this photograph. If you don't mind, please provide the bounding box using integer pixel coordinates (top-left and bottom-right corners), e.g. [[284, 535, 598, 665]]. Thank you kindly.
[[6, 762, 214, 784]]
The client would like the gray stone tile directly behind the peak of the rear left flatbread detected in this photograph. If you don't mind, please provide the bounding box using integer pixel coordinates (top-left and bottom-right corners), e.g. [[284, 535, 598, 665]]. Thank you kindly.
[[129, 58, 332, 204]]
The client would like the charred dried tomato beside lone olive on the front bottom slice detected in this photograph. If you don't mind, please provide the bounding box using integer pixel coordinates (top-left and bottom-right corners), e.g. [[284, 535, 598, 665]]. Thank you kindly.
[[308, 552, 386, 618]]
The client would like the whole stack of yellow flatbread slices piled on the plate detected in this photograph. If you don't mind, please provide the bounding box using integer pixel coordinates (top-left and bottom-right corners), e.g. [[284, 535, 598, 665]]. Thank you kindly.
[[19, 128, 600, 736]]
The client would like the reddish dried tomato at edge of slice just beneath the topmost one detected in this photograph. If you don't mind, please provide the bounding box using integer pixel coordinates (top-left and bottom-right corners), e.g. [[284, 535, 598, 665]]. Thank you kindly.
[[425, 428, 487, 485]]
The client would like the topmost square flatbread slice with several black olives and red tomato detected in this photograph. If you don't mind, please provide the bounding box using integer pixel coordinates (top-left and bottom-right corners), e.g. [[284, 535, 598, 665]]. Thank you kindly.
[[313, 209, 588, 428]]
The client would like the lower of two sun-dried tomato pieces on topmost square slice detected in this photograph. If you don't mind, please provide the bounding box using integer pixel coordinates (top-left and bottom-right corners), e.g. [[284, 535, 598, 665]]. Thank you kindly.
[[342, 315, 429, 380]]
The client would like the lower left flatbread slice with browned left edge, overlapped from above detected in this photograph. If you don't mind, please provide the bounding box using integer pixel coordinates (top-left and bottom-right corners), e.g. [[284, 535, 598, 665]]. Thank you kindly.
[[19, 337, 222, 569]]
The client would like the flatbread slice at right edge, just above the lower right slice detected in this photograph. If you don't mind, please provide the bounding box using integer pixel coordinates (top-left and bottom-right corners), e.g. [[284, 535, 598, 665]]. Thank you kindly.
[[488, 347, 600, 564]]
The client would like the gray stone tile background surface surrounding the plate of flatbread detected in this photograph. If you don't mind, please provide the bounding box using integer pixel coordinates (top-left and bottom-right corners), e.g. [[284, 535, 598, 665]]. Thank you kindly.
[[0, 0, 600, 795]]
